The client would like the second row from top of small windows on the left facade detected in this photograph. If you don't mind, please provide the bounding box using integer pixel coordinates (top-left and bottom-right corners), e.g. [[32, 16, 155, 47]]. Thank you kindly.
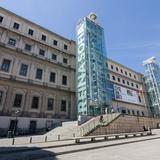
[[8, 38, 68, 64]]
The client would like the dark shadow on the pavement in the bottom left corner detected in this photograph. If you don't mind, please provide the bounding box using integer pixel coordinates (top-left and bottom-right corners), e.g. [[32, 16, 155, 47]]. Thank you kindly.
[[0, 147, 58, 160]]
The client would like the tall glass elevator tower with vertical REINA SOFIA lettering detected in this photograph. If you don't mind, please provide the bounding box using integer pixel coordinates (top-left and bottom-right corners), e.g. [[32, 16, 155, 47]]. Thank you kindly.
[[76, 13, 112, 116]]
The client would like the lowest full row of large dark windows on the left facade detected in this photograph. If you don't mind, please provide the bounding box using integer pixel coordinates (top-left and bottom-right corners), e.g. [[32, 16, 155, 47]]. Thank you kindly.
[[0, 91, 67, 112]]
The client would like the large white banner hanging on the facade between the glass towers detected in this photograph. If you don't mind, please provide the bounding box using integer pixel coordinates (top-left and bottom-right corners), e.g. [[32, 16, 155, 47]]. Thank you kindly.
[[114, 85, 140, 104]]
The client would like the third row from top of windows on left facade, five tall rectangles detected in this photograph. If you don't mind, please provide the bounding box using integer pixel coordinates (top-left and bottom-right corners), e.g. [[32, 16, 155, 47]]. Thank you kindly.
[[1, 59, 67, 85]]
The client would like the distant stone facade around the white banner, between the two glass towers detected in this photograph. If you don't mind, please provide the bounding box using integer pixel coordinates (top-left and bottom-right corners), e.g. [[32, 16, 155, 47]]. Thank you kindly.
[[107, 59, 148, 116]]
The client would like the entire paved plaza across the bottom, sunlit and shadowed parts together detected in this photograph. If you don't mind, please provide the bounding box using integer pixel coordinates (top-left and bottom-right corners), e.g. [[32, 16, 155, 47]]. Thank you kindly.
[[0, 130, 160, 160]]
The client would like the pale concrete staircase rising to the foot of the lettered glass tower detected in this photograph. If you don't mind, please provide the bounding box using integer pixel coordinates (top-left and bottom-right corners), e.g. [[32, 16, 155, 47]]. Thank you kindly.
[[45, 113, 120, 139]]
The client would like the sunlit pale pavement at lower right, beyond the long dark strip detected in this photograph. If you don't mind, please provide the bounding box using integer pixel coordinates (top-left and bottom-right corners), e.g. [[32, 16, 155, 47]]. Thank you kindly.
[[55, 136, 160, 160]]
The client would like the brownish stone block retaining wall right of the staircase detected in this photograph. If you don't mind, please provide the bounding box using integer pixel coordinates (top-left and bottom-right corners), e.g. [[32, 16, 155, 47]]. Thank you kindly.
[[89, 115, 160, 136]]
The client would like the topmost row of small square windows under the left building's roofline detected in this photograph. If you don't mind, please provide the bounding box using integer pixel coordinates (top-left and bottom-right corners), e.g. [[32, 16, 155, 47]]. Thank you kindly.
[[0, 16, 68, 50]]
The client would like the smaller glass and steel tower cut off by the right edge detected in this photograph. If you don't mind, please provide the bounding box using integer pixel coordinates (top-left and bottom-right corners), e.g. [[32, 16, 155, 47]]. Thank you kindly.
[[143, 57, 160, 116]]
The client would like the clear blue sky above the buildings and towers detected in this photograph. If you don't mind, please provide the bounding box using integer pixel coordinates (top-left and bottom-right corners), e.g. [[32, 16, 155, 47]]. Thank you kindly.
[[0, 0, 160, 72]]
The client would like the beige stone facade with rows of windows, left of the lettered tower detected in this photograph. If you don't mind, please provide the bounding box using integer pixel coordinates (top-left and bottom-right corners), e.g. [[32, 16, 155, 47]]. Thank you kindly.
[[0, 8, 76, 135]]
